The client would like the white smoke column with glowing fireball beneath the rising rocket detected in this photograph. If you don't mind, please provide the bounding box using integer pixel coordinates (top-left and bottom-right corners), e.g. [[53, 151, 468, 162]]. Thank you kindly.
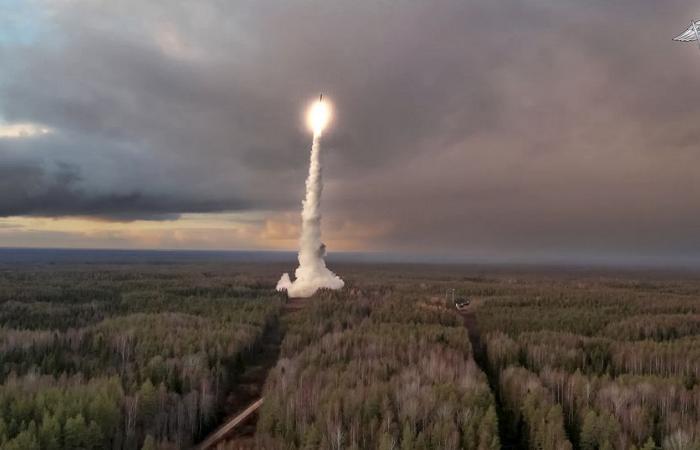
[[277, 96, 345, 298]]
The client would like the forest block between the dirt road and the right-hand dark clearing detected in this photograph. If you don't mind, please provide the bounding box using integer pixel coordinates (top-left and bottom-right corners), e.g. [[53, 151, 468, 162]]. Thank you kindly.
[[256, 289, 500, 450]]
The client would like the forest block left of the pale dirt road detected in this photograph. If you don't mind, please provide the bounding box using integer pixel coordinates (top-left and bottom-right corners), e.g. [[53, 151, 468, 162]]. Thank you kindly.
[[0, 265, 280, 450]]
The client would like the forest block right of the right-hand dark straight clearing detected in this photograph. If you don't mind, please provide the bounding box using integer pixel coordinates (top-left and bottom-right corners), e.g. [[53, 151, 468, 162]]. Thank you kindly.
[[477, 279, 700, 450]]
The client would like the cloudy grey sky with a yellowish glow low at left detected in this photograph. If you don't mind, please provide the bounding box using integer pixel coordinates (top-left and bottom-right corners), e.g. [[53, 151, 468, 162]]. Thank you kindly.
[[0, 0, 700, 262]]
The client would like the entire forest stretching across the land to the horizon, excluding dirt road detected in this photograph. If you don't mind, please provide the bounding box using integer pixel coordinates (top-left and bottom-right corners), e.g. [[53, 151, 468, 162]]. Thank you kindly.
[[0, 263, 700, 450]]
